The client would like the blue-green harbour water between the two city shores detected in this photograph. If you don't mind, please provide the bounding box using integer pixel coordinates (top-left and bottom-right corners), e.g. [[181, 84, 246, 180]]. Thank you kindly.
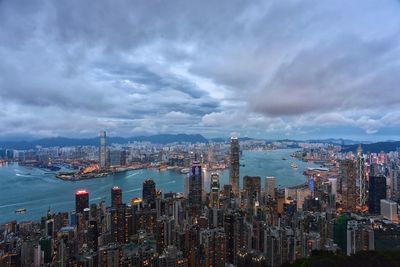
[[0, 149, 315, 223]]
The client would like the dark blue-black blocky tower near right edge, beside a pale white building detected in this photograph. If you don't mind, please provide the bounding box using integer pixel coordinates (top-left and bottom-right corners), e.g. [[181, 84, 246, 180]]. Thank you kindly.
[[368, 175, 386, 214]]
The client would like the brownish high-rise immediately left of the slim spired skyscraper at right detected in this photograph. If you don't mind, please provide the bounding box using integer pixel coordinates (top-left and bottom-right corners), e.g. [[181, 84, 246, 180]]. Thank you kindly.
[[339, 160, 358, 211]]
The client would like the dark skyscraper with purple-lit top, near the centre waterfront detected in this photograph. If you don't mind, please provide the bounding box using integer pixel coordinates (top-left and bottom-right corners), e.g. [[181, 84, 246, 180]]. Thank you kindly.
[[188, 161, 203, 217]]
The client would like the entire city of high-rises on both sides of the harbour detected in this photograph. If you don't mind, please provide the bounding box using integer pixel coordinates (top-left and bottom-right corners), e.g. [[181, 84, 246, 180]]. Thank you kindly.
[[0, 135, 400, 266]]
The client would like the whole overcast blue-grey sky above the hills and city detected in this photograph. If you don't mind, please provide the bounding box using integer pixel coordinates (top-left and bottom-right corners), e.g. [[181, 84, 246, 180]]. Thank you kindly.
[[0, 0, 400, 140]]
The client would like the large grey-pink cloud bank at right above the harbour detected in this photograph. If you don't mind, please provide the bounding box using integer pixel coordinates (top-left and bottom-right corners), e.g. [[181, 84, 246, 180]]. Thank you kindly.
[[250, 35, 400, 116]]
